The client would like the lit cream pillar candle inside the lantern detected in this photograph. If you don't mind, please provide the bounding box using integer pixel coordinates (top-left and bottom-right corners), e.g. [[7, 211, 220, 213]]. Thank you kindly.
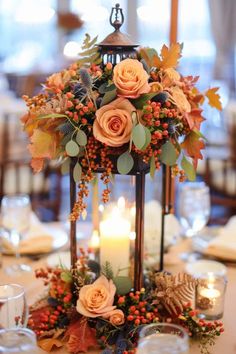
[[100, 208, 130, 275]]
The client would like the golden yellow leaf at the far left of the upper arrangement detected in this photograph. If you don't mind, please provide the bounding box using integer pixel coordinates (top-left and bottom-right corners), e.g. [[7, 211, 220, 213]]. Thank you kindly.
[[29, 129, 56, 158]]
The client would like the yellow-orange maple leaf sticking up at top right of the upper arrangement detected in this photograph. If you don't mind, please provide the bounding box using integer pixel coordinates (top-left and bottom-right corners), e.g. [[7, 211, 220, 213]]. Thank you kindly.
[[158, 43, 181, 69]]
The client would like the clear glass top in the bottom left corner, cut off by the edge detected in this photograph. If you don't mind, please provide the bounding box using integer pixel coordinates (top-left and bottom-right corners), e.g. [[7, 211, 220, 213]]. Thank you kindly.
[[0, 328, 38, 354]]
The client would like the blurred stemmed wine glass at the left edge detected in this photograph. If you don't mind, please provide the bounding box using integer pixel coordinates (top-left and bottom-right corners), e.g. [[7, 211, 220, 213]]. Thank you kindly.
[[1, 194, 31, 274]]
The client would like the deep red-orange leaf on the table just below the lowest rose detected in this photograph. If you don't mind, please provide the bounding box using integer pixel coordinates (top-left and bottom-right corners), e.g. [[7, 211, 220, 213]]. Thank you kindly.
[[65, 317, 97, 354]]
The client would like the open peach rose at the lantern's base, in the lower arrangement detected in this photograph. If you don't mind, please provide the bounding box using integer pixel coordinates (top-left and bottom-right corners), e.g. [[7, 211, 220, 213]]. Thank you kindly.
[[76, 275, 116, 317]]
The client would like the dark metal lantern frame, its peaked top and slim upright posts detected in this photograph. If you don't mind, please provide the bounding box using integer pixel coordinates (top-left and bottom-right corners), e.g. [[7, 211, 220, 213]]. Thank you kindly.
[[70, 4, 172, 290]]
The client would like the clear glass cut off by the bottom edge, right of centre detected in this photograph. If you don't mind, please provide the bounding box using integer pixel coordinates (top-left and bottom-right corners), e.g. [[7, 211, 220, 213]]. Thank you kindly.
[[138, 323, 189, 354]]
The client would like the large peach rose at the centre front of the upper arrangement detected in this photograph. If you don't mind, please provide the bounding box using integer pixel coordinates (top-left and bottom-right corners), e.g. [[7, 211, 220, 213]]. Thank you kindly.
[[93, 98, 135, 146]]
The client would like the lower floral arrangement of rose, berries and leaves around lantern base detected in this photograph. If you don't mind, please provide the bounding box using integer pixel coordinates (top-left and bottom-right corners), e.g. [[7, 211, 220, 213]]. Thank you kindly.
[[28, 250, 224, 354]]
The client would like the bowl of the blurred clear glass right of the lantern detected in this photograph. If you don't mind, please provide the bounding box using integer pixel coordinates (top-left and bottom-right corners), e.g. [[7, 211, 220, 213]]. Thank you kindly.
[[179, 182, 210, 237]]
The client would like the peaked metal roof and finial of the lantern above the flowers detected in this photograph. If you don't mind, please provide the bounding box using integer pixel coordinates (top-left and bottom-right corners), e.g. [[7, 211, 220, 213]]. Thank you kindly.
[[98, 4, 139, 65]]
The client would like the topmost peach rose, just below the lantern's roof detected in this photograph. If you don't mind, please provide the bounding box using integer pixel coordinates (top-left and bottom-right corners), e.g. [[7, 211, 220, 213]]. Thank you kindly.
[[113, 59, 150, 98]]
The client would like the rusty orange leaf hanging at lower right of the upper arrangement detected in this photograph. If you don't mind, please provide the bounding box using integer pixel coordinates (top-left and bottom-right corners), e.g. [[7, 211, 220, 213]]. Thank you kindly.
[[181, 131, 205, 168]]
